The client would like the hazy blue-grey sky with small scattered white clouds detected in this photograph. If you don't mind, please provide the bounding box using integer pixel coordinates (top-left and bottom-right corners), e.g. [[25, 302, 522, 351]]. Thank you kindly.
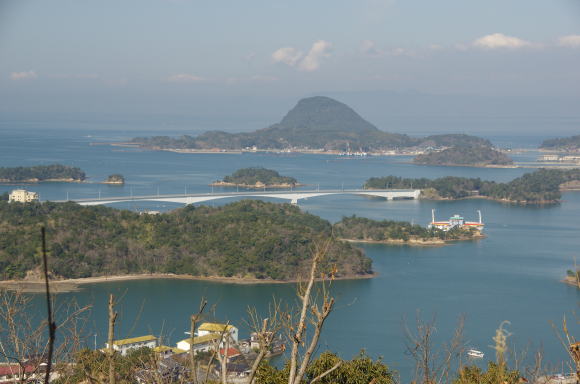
[[0, 0, 580, 131]]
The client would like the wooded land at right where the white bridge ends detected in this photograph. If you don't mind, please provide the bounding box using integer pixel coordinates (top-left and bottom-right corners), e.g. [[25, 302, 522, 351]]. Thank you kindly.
[[364, 169, 580, 204]]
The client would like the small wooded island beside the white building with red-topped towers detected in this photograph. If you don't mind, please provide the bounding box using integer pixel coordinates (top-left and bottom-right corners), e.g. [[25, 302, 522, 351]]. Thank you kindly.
[[333, 215, 484, 245]]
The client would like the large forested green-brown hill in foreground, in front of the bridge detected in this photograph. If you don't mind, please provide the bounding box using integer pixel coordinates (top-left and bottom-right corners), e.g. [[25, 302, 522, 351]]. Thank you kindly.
[[0, 200, 372, 281]]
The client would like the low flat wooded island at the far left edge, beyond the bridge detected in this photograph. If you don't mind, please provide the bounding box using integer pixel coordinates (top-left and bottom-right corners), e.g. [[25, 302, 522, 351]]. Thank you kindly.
[[0, 164, 86, 183]]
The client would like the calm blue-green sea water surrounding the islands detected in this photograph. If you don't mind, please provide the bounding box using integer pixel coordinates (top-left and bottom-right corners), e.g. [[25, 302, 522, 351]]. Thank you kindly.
[[0, 130, 580, 378]]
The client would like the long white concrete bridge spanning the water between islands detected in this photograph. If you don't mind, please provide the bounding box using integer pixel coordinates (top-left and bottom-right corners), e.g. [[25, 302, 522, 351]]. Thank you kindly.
[[58, 189, 421, 205]]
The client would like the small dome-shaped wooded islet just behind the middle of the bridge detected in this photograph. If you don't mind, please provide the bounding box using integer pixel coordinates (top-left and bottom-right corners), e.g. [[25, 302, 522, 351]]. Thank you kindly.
[[210, 167, 302, 189]]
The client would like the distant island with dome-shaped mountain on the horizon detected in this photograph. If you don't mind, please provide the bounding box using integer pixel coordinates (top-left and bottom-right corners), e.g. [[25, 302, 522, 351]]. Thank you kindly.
[[132, 96, 491, 152]]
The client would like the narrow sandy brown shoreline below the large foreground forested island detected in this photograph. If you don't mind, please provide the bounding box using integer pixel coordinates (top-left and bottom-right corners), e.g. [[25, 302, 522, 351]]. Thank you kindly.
[[0, 272, 378, 293]]
